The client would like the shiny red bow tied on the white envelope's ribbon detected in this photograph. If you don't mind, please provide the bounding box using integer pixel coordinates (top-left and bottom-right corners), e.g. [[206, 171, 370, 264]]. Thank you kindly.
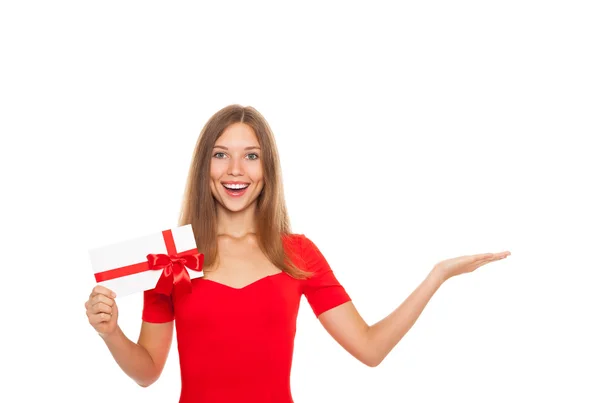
[[147, 253, 204, 295]]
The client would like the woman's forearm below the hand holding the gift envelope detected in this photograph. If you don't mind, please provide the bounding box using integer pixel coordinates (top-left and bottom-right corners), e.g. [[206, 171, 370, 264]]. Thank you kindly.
[[103, 326, 160, 387]]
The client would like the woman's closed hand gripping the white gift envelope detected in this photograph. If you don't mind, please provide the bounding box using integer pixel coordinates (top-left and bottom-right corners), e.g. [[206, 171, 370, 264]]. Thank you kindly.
[[85, 285, 119, 338]]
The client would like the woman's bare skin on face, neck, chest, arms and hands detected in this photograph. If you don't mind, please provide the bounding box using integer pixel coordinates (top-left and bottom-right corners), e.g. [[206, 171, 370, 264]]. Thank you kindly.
[[85, 123, 510, 387]]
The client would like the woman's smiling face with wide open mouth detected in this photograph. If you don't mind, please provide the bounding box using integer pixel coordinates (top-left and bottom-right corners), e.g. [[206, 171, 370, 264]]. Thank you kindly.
[[210, 123, 264, 212]]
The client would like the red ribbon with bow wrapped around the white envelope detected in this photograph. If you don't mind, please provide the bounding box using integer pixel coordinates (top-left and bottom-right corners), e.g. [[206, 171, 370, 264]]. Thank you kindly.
[[95, 230, 204, 295]]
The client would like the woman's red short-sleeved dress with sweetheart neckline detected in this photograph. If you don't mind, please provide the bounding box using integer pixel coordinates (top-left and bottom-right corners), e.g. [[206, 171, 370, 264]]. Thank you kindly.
[[142, 234, 350, 403]]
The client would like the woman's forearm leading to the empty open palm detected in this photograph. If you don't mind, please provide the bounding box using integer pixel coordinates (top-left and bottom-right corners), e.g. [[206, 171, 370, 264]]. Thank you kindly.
[[367, 270, 444, 366]]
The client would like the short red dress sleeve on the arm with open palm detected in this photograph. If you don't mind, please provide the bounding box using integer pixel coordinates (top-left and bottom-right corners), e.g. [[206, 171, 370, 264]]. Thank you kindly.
[[300, 235, 351, 317]]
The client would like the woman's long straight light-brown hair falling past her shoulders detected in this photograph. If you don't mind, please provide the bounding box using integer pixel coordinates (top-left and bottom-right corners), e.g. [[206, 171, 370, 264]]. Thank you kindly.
[[179, 105, 309, 278]]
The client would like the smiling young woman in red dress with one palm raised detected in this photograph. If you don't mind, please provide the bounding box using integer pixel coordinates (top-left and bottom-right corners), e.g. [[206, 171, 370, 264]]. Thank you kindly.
[[85, 105, 510, 403]]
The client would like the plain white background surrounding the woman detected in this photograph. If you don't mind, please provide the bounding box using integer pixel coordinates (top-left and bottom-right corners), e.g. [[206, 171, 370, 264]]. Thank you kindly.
[[0, 0, 600, 403]]
